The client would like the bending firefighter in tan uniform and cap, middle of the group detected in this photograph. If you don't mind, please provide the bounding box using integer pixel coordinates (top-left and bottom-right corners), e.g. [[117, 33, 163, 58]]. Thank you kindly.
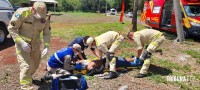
[[86, 31, 124, 79]]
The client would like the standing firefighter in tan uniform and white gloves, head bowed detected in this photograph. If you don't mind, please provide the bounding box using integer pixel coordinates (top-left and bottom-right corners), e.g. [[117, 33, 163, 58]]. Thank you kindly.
[[8, 2, 51, 90]]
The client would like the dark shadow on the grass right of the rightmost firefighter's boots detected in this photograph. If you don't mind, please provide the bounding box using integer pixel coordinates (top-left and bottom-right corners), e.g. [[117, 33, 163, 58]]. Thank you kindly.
[[148, 64, 172, 76]]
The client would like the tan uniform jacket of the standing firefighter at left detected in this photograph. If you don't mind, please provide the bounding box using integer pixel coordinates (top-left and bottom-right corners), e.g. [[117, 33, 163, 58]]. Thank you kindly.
[[8, 7, 51, 51]]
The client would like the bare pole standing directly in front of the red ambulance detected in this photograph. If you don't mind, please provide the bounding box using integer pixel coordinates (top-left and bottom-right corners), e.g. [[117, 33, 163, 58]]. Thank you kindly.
[[173, 0, 185, 42]]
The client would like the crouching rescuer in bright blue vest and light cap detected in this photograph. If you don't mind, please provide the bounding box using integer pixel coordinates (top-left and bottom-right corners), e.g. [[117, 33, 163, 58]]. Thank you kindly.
[[41, 44, 82, 80]]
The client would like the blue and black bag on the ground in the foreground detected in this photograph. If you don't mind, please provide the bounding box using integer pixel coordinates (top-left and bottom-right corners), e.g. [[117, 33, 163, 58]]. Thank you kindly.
[[50, 75, 88, 90]]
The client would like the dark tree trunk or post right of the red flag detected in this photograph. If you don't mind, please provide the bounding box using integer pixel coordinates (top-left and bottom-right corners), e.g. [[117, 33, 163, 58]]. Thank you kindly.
[[132, 0, 139, 32]]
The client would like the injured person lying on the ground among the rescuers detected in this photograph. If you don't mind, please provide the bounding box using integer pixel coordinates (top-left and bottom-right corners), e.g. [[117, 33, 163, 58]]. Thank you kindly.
[[76, 57, 143, 76]]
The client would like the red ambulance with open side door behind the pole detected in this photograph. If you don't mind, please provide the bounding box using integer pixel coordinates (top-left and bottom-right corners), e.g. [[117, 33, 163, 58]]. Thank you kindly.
[[141, 0, 200, 38]]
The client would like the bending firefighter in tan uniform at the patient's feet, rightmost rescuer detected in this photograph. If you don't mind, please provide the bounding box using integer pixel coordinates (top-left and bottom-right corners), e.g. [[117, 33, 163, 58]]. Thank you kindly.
[[127, 29, 165, 78]]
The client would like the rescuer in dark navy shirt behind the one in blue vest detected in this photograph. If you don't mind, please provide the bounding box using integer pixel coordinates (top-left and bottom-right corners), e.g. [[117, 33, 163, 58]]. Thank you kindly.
[[69, 36, 97, 60]]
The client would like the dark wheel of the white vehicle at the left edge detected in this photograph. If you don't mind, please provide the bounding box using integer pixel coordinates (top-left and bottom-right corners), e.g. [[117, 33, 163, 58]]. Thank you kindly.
[[0, 26, 7, 44]]
